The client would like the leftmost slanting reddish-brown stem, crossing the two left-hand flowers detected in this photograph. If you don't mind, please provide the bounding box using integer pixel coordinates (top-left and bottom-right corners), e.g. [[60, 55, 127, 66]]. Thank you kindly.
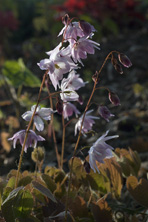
[[15, 70, 49, 188]]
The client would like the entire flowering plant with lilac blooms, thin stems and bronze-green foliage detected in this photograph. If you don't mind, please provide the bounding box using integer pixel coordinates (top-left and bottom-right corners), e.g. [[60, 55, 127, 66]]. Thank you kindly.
[[1, 15, 148, 222]]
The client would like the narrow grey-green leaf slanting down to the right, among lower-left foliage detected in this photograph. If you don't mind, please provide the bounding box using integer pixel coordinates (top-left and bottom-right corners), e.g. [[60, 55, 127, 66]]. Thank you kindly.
[[32, 181, 57, 203]]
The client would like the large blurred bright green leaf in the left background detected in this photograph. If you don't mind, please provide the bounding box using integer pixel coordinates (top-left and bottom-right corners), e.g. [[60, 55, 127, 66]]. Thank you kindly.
[[2, 59, 41, 88]]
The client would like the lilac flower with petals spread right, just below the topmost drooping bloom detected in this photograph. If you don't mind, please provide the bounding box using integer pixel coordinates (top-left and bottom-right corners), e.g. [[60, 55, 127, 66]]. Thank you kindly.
[[69, 38, 100, 65]]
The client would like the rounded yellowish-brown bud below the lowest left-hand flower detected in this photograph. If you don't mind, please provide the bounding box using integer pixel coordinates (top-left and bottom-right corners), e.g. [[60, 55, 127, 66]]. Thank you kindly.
[[31, 147, 45, 163]]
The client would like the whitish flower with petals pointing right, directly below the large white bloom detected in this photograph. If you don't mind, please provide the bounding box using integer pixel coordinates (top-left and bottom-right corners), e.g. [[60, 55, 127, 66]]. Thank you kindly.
[[62, 70, 88, 90]]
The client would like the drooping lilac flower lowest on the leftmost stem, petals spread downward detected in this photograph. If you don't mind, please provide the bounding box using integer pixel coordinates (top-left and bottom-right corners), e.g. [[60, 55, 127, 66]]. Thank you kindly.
[[8, 130, 45, 152]]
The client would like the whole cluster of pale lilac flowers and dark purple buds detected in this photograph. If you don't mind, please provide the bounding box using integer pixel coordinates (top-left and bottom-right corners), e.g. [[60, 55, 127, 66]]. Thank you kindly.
[[9, 15, 131, 171]]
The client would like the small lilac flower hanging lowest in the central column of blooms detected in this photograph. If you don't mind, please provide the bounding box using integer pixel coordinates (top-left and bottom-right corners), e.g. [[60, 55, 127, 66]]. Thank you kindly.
[[63, 102, 80, 120]]
